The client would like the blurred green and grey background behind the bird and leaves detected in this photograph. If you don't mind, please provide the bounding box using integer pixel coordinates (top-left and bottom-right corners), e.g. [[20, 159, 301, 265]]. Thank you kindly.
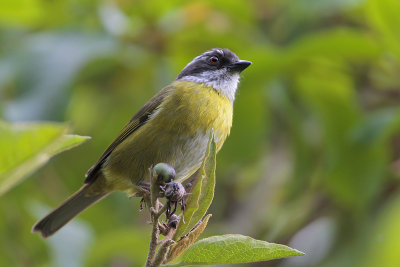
[[0, 0, 400, 267]]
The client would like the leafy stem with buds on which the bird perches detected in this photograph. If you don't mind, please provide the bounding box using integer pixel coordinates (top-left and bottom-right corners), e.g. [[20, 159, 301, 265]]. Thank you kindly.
[[148, 134, 304, 266]]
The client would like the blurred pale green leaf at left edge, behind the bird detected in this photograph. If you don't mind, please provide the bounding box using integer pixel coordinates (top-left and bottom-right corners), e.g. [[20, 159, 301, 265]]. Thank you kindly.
[[0, 121, 90, 196]]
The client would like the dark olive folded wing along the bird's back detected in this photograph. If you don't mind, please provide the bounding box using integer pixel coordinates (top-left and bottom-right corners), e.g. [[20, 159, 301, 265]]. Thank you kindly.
[[85, 86, 173, 183]]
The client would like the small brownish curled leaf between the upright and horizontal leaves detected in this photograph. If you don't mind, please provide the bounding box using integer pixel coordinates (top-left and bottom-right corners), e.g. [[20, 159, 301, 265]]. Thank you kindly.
[[166, 214, 211, 262]]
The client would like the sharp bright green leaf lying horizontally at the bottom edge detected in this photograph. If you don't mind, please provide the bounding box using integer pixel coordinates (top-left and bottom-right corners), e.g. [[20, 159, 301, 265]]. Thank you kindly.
[[178, 235, 304, 265]]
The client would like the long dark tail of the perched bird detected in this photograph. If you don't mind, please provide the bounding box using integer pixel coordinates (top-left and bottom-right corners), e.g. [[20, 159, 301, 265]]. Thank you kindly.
[[32, 184, 107, 238]]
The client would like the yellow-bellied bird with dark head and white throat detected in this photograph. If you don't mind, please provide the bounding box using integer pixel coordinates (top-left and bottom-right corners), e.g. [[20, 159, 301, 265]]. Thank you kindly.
[[32, 48, 252, 238]]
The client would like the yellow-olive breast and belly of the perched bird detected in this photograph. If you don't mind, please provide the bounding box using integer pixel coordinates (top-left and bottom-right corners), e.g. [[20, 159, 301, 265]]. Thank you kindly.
[[102, 81, 232, 195]]
